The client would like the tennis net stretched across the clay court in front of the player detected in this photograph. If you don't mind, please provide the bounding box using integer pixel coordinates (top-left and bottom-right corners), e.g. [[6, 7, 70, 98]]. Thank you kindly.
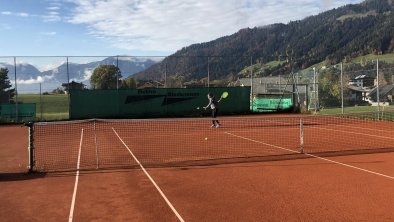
[[26, 112, 394, 172]]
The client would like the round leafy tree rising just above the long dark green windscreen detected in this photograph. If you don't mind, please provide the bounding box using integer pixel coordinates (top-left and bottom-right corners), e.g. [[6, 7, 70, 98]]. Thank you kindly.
[[90, 65, 122, 89]]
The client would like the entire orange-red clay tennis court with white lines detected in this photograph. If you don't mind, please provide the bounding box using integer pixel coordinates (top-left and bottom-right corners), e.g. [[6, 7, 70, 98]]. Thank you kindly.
[[0, 113, 394, 221]]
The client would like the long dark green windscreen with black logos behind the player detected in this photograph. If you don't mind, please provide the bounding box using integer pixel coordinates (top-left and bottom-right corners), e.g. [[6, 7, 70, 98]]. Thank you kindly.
[[70, 87, 250, 119]]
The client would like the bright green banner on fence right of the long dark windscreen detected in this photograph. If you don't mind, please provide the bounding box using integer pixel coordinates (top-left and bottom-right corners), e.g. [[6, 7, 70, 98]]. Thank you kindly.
[[250, 98, 293, 112]]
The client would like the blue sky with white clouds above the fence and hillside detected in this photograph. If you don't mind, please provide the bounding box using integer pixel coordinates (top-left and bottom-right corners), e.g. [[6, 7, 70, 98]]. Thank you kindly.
[[0, 0, 363, 56]]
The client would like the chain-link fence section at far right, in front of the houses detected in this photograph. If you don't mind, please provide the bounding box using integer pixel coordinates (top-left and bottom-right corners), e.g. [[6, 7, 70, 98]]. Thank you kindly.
[[310, 57, 394, 113]]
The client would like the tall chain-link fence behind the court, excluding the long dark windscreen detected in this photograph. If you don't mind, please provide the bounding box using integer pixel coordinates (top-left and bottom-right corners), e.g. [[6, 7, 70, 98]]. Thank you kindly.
[[0, 55, 394, 121]]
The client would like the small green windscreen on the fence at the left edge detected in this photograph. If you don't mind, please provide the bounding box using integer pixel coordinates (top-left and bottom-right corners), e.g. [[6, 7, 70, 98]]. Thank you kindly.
[[0, 103, 36, 121]]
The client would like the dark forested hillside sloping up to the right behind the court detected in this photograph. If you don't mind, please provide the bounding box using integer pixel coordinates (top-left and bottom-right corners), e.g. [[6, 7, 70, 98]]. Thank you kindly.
[[133, 0, 394, 81]]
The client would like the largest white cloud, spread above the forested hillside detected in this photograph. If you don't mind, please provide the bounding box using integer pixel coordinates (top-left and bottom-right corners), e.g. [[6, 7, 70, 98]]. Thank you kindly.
[[68, 0, 362, 51]]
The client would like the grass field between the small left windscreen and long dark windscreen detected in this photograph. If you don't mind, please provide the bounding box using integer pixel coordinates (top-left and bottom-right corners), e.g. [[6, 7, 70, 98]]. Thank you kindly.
[[18, 94, 69, 120]]
